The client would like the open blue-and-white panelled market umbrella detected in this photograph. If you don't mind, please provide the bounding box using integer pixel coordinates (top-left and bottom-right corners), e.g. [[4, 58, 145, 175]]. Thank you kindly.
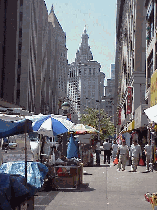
[[33, 115, 74, 136]]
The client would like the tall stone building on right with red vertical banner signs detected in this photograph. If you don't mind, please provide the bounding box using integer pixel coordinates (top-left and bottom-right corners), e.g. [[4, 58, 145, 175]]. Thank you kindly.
[[114, 0, 147, 133]]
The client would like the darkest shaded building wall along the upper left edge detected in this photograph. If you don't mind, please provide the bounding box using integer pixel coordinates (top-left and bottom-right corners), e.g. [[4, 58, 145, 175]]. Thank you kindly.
[[0, 1, 19, 103]]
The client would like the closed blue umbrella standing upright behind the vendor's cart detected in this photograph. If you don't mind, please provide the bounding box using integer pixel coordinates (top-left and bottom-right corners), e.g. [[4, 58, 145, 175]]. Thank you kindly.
[[67, 134, 78, 159]]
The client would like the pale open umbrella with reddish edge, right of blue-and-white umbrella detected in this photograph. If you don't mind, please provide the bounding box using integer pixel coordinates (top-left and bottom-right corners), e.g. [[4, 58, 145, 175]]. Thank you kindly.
[[70, 124, 99, 134]]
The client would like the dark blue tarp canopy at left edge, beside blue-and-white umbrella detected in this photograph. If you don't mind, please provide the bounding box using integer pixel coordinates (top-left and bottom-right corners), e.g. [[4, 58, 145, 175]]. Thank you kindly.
[[0, 119, 33, 138]]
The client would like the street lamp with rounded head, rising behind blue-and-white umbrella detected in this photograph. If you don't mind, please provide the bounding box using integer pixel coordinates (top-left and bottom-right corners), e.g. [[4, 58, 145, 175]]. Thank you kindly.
[[61, 102, 70, 156]]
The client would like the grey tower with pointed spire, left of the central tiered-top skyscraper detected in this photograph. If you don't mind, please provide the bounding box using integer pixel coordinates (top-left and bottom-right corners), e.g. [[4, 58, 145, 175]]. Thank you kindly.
[[48, 6, 68, 111]]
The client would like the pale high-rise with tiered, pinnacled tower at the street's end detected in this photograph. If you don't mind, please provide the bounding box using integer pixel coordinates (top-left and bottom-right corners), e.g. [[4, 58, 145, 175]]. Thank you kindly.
[[67, 28, 104, 121]]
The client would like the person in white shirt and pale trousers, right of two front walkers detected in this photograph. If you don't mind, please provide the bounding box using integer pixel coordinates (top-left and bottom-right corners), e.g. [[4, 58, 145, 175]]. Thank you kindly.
[[130, 139, 142, 172]]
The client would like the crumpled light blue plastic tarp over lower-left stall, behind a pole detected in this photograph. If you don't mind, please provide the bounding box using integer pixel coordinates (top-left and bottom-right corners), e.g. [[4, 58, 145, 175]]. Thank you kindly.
[[0, 161, 48, 189]]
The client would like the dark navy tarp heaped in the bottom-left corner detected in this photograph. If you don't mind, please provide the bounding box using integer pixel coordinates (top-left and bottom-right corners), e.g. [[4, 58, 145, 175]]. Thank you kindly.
[[0, 173, 37, 210]]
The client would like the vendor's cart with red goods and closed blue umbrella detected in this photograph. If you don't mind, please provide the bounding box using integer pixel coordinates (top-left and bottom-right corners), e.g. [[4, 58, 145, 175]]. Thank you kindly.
[[43, 135, 83, 189]]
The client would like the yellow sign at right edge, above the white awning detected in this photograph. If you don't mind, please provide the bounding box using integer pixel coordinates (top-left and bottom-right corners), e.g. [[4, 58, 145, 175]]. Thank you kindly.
[[150, 70, 157, 106]]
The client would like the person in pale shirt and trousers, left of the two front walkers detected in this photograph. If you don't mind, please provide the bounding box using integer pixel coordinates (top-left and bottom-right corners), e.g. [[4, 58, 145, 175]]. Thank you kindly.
[[117, 137, 129, 171]]
